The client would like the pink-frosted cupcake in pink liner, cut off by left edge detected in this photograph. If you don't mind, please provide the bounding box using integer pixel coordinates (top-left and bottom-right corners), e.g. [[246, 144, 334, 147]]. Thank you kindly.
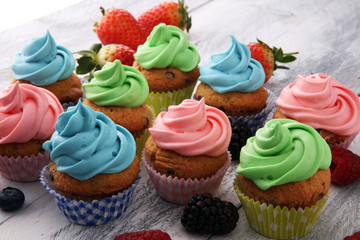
[[0, 82, 63, 181]]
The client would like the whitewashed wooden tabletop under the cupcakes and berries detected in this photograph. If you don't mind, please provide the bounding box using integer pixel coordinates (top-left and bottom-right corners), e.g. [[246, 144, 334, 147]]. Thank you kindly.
[[0, 0, 360, 240]]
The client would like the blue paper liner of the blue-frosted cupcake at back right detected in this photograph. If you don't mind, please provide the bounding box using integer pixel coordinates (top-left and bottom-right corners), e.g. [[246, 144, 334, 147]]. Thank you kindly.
[[228, 89, 276, 135]]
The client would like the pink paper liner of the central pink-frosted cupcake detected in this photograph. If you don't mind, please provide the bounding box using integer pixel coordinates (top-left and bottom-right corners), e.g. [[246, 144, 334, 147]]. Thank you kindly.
[[143, 150, 231, 204]]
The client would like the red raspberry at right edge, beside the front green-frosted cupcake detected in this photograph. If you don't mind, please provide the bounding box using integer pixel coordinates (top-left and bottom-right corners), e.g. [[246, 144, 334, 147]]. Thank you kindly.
[[330, 147, 360, 185]]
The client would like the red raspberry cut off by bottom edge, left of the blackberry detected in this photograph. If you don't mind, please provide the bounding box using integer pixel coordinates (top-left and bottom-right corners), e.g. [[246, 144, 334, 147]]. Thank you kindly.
[[114, 230, 171, 240]]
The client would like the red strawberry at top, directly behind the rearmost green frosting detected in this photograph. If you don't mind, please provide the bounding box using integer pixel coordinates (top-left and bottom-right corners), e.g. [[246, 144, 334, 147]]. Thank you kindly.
[[137, 0, 191, 36]]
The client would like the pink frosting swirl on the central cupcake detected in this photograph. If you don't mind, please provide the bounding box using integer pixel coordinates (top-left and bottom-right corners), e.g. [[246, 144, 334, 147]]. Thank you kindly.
[[149, 99, 231, 157]]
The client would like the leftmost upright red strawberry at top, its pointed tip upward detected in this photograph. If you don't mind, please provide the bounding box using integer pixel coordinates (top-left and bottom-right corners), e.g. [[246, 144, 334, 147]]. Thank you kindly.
[[95, 8, 146, 50]]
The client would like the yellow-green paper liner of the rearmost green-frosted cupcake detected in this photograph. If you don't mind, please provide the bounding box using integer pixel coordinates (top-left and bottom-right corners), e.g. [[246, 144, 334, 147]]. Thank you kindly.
[[145, 83, 196, 116]]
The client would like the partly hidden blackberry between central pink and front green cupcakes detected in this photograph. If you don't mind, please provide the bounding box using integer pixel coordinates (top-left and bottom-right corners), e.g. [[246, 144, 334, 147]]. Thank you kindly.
[[228, 120, 253, 161]]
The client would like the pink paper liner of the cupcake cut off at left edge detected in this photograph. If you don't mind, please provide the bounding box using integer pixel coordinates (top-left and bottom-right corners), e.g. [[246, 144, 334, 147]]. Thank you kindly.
[[0, 151, 51, 182]]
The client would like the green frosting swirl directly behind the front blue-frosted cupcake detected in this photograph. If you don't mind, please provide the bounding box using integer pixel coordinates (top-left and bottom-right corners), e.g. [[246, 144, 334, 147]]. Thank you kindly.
[[82, 60, 149, 107]]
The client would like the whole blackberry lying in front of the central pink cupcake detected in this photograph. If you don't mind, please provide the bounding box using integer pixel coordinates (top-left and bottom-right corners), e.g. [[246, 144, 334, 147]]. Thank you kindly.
[[181, 194, 239, 234]]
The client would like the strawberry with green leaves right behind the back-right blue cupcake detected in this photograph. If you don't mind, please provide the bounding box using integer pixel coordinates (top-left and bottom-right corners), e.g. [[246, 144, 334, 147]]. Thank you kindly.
[[247, 39, 298, 82]]
